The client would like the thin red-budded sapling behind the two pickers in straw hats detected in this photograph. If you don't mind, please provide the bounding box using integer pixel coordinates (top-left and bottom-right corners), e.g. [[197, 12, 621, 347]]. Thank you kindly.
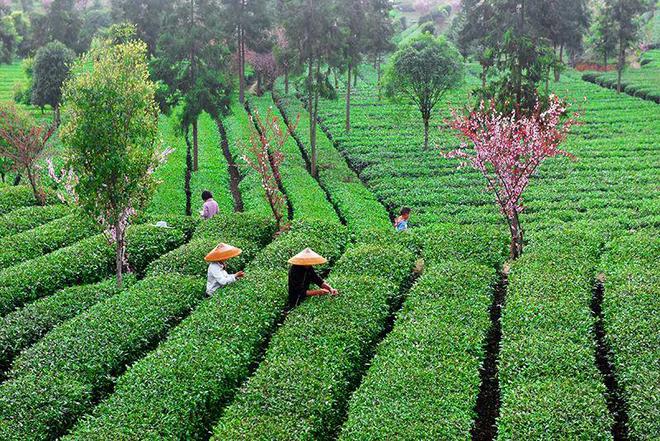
[[243, 108, 300, 231]]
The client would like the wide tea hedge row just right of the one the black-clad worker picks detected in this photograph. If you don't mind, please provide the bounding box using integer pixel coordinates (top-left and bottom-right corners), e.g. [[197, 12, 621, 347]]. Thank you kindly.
[[340, 260, 496, 440]]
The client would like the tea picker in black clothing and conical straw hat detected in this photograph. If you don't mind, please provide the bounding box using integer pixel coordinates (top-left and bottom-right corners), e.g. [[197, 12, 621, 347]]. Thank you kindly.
[[288, 248, 338, 308]]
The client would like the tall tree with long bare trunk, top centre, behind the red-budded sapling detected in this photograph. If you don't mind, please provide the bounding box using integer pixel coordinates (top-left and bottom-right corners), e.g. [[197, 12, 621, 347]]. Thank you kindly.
[[280, 0, 342, 176]]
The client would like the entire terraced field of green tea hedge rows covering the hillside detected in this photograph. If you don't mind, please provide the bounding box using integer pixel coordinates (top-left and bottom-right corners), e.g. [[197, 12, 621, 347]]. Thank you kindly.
[[0, 59, 660, 441]]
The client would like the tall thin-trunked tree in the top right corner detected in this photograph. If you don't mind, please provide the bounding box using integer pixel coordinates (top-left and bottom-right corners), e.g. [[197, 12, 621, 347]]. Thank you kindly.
[[605, 0, 649, 93]]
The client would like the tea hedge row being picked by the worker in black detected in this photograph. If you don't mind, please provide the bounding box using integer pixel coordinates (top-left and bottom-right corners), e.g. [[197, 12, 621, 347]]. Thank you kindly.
[[213, 274, 397, 440]]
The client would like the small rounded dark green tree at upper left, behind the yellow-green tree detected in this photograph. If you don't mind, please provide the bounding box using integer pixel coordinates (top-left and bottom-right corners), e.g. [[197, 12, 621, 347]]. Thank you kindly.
[[32, 41, 76, 125]]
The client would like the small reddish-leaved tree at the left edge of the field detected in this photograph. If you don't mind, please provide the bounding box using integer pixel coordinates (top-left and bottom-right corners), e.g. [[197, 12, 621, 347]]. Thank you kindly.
[[0, 104, 55, 205]]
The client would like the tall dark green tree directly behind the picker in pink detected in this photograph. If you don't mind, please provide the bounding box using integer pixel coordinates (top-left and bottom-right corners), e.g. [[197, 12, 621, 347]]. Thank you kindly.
[[151, 0, 231, 171]]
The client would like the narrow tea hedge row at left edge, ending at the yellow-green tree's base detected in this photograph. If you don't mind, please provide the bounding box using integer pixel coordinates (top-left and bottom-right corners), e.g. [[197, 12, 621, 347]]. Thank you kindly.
[[0, 276, 135, 372]]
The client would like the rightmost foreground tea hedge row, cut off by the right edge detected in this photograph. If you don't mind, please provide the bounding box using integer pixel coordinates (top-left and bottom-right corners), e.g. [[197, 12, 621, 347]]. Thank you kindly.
[[601, 228, 660, 440]]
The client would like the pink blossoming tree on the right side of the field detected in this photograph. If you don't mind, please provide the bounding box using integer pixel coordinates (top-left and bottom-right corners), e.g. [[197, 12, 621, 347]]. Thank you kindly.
[[444, 95, 578, 259]]
